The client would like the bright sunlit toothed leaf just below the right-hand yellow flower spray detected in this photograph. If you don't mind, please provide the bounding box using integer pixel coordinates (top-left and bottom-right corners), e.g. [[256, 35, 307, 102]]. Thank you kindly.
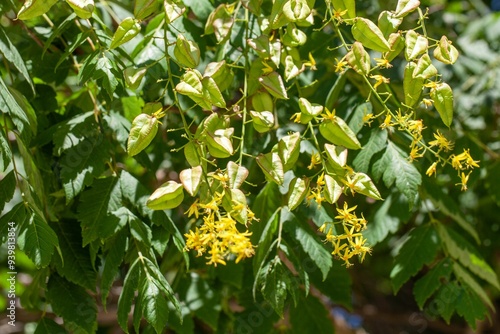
[[373, 141, 422, 207]]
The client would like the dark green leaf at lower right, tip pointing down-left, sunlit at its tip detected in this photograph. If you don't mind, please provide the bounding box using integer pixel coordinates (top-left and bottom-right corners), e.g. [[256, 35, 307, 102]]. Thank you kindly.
[[391, 224, 440, 292]]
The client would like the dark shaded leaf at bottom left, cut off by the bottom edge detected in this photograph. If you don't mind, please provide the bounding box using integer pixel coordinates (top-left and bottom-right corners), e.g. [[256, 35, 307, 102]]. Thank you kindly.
[[46, 274, 97, 333]]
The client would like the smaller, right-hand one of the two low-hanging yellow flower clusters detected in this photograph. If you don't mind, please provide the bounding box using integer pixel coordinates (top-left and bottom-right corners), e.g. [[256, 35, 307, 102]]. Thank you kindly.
[[319, 202, 371, 267]]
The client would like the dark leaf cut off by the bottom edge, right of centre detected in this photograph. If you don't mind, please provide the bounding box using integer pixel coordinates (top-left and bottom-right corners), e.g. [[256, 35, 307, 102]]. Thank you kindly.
[[290, 295, 335, 334]]
